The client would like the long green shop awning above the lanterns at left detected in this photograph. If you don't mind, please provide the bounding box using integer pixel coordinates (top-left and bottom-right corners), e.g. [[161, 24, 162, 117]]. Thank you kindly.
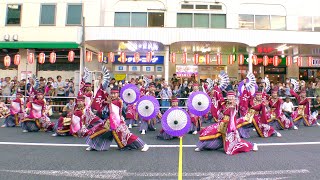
[[0, 41, 79, 49]]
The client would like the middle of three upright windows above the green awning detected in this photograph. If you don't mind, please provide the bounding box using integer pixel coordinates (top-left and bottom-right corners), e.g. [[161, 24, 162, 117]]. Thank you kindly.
[[40, 5, 56, 25]]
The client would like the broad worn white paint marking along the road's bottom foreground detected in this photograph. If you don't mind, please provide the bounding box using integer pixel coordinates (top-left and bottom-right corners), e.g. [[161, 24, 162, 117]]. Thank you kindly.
[[0, 169, 310, 180]]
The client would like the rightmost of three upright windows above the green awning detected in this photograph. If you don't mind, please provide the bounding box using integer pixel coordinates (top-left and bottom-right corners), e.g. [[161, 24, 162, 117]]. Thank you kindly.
[[67, 4, 82, 25]]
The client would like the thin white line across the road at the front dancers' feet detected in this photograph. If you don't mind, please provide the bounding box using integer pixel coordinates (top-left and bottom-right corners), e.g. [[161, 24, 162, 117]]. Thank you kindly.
[[0, 142, 320, 148]]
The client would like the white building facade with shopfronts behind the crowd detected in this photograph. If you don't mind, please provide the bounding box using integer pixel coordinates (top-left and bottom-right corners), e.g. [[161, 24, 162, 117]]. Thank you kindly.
[[0, 0, 320, 85]]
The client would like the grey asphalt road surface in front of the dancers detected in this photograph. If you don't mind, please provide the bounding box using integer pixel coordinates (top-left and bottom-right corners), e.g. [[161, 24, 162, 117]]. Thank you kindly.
[[0, 119, 320, 180]]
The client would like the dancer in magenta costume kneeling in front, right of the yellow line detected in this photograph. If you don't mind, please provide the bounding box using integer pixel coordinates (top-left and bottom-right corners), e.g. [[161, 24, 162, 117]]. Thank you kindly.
[[195, 91, 258, 155]]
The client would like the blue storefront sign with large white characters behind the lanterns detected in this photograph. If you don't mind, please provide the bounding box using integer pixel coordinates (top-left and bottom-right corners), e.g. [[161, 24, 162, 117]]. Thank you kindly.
[[113, 56, 164, 64]]
